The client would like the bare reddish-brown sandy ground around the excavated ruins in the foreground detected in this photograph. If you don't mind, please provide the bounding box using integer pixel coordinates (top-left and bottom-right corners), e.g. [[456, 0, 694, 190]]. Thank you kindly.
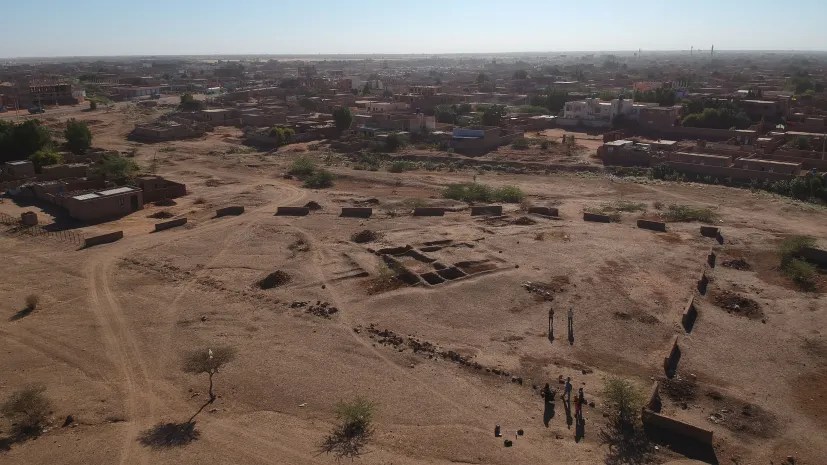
[[0, 107, 827, 464]]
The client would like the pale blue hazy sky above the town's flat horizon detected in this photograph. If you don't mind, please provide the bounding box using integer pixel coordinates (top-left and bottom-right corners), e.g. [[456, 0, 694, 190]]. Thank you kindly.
[[0, 0, 827, 58]]
